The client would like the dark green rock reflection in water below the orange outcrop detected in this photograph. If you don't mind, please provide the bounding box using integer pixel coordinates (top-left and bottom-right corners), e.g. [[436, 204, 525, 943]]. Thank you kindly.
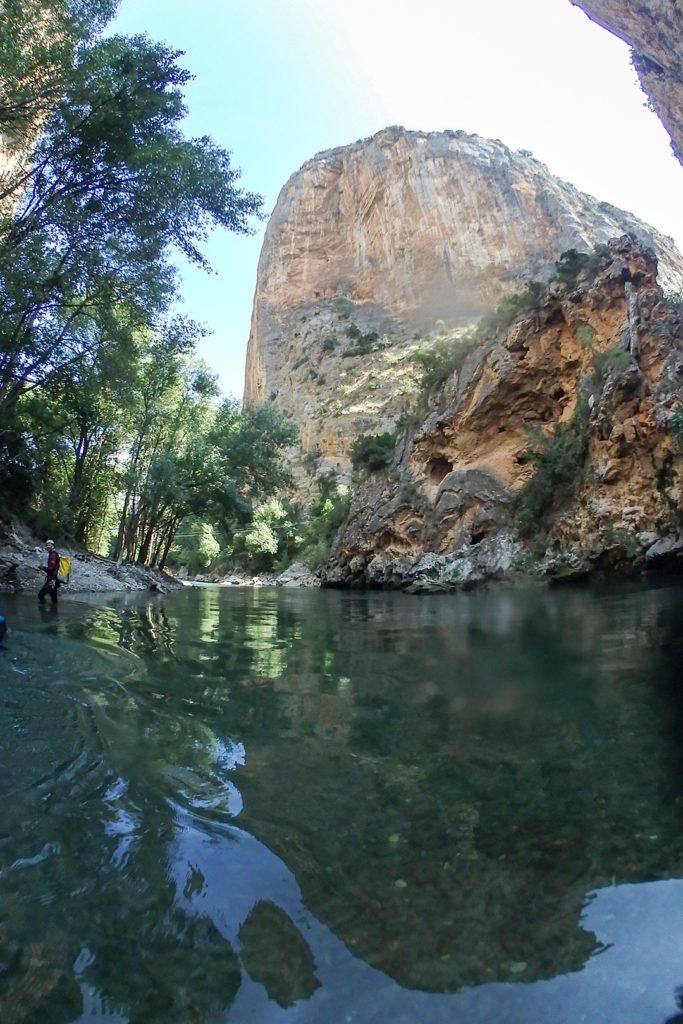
[[231, 594, 681, 991]]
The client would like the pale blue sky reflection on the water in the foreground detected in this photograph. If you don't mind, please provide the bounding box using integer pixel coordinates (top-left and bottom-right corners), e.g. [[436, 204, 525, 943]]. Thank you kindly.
[[169, 828, 683, 1024]]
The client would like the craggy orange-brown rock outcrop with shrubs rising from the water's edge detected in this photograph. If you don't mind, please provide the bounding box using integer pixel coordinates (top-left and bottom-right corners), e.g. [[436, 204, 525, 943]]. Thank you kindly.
[[326, 237, 683, 591]]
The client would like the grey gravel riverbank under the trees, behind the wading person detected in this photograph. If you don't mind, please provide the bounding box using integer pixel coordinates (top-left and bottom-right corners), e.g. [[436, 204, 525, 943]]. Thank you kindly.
[[0, 525, 321, 594]]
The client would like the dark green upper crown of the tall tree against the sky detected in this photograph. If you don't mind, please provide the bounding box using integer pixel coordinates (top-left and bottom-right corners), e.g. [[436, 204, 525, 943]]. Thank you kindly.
[[0, 30, 261, 429]]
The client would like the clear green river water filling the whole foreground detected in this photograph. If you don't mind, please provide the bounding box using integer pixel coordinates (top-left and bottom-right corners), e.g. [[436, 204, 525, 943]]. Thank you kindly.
[[0, 583, 683, 1024]]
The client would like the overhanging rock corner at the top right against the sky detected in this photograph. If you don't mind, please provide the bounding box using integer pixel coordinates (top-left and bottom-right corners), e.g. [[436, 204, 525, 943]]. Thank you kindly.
[[571, 0, 683, 163]]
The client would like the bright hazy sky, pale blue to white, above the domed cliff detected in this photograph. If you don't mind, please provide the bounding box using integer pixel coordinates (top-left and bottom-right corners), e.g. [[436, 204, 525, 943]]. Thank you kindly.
[[109, 0, 683, 396]]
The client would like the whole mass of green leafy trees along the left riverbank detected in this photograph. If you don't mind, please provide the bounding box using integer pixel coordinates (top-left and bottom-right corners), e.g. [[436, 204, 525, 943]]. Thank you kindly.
[[0, 0, 295, 566]]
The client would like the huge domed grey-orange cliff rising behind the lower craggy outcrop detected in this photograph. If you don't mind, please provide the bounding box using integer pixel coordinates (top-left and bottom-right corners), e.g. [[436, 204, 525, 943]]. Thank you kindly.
[[245, 128, 683, 493]]
